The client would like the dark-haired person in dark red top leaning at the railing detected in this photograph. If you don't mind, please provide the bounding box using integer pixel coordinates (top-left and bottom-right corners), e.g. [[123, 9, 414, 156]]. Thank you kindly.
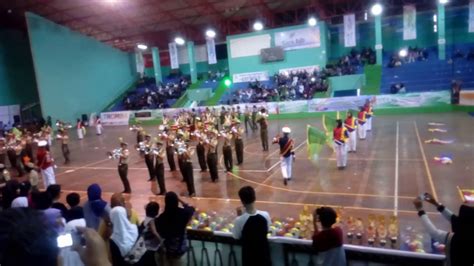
[[313, 207, 347, 266]]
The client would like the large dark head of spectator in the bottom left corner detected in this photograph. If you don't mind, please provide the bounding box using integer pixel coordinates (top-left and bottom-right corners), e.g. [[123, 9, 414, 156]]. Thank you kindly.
[[0, 208, 59, 266]]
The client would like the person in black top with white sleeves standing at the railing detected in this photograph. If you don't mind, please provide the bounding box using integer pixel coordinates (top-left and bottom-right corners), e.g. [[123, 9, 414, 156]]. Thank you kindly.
[[232, 186, 272, 266]]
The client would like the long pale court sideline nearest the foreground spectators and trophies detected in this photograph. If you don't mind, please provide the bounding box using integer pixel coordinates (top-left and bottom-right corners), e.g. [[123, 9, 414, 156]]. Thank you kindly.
[[62, 190, 439, 215]]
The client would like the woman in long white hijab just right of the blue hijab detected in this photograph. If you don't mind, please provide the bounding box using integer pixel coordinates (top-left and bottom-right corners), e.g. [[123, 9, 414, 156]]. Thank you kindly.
[[110, 206, 138, 266]]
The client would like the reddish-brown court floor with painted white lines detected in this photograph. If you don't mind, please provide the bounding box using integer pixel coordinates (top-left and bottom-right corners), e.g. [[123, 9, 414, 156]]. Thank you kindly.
[[26, 113, 474, 235]]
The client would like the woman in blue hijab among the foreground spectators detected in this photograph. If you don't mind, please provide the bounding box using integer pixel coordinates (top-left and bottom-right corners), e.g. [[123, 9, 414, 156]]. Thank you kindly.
[[83, 184, 110, 231]]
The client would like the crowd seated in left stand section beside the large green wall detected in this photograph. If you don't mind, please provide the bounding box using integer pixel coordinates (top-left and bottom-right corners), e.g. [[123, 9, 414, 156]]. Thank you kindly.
[[123, 78, 190, 110]]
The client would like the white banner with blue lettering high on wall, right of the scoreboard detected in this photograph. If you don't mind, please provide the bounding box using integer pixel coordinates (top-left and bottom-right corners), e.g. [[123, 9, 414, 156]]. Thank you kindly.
[[275, 26, 321, 51]]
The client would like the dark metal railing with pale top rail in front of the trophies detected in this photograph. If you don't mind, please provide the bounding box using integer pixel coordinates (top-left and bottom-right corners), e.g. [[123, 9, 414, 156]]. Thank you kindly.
[[186, 230, 445, 266]]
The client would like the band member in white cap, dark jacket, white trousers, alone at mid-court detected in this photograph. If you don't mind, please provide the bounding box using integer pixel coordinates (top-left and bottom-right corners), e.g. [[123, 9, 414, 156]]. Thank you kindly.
[[273, 127, 294, 186]]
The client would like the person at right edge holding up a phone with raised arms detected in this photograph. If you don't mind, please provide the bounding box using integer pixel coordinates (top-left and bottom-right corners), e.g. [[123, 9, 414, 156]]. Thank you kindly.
[[413, 193, 474, 266]]
